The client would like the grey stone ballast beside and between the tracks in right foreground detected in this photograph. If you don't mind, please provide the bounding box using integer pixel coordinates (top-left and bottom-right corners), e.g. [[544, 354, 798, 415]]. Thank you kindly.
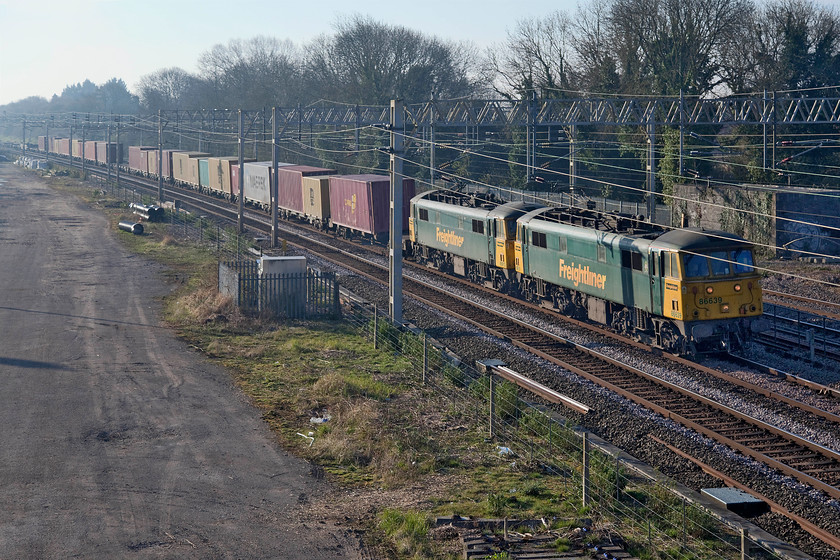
[[302, 238, 840, 559]]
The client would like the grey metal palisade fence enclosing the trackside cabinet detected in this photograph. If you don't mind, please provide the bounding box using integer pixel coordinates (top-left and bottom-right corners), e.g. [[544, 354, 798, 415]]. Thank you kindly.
[[219, 261, 341, 319]]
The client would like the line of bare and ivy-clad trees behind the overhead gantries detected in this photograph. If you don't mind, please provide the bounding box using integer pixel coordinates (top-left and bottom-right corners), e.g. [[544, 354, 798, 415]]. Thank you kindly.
[[0, 0, 840, 199]]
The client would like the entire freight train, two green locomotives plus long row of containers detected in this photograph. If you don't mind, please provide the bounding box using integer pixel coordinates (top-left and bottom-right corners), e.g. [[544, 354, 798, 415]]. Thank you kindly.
[[38, 137, 763, 355]]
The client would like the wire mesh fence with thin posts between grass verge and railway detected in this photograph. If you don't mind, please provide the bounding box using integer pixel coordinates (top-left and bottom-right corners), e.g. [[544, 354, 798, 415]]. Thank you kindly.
[[343, 301, 779, 560]]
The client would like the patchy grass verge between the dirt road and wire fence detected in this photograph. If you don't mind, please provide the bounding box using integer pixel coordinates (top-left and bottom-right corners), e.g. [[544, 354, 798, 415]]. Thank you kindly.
[[42, 171, 748, 559]]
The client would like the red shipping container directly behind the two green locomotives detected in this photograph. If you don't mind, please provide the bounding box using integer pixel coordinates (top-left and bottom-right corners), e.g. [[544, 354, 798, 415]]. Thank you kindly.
[[330, 175, 414, 240]]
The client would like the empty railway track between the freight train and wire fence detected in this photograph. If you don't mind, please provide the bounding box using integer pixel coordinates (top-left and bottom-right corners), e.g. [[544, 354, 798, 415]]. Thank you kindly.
[[29, 151, 840, 548]]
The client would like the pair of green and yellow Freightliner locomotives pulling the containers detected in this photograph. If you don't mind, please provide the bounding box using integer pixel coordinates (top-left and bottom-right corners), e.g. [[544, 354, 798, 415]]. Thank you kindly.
[[406, 190, 762, 355]]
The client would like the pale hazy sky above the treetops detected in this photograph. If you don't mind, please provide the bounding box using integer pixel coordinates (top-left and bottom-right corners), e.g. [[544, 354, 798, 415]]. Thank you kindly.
[[0, 0, 585, 105]]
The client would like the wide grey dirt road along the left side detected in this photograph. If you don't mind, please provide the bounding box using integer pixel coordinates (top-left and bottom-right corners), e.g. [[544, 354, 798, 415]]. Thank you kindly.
[[0, 165, 361, 560]]
